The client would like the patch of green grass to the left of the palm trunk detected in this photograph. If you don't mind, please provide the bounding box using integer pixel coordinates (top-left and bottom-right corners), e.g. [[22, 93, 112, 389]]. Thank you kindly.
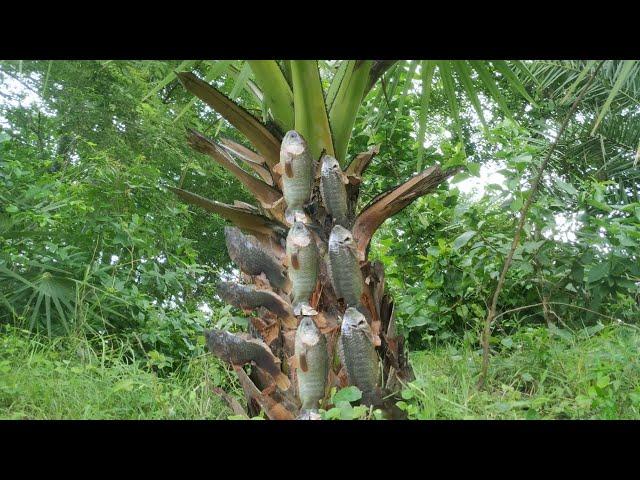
[[0, 329, 241, 419]]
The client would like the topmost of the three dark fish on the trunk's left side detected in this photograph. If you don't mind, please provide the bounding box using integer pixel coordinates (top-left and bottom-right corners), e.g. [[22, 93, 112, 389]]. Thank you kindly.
[[224, 227, 291, 291]]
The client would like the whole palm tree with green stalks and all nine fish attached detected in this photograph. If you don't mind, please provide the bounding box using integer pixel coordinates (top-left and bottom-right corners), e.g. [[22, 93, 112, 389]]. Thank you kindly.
[[172, 60, 456, 419]]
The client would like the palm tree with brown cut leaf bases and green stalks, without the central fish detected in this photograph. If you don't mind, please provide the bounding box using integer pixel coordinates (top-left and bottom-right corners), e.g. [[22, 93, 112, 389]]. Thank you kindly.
[[168, 60, 468, 419]]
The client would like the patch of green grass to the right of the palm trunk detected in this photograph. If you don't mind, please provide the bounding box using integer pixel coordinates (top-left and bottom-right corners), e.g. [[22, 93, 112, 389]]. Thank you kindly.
[[402, 325, 640, 419]]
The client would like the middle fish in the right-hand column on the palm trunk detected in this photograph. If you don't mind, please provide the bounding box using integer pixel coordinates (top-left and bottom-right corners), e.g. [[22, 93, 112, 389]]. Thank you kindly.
[[327, 225, 364, 307]]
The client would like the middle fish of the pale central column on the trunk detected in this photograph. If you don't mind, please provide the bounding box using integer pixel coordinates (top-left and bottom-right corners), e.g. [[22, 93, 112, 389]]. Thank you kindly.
[[287, 222, 319, 307]]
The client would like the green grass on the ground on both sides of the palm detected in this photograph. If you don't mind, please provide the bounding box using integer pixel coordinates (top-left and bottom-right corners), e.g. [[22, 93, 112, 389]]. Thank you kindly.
[[0, 325, 640, 419]]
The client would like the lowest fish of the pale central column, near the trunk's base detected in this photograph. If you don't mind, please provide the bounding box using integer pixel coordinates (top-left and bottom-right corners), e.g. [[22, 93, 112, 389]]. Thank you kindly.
[[295, 317, 329, 410]]
